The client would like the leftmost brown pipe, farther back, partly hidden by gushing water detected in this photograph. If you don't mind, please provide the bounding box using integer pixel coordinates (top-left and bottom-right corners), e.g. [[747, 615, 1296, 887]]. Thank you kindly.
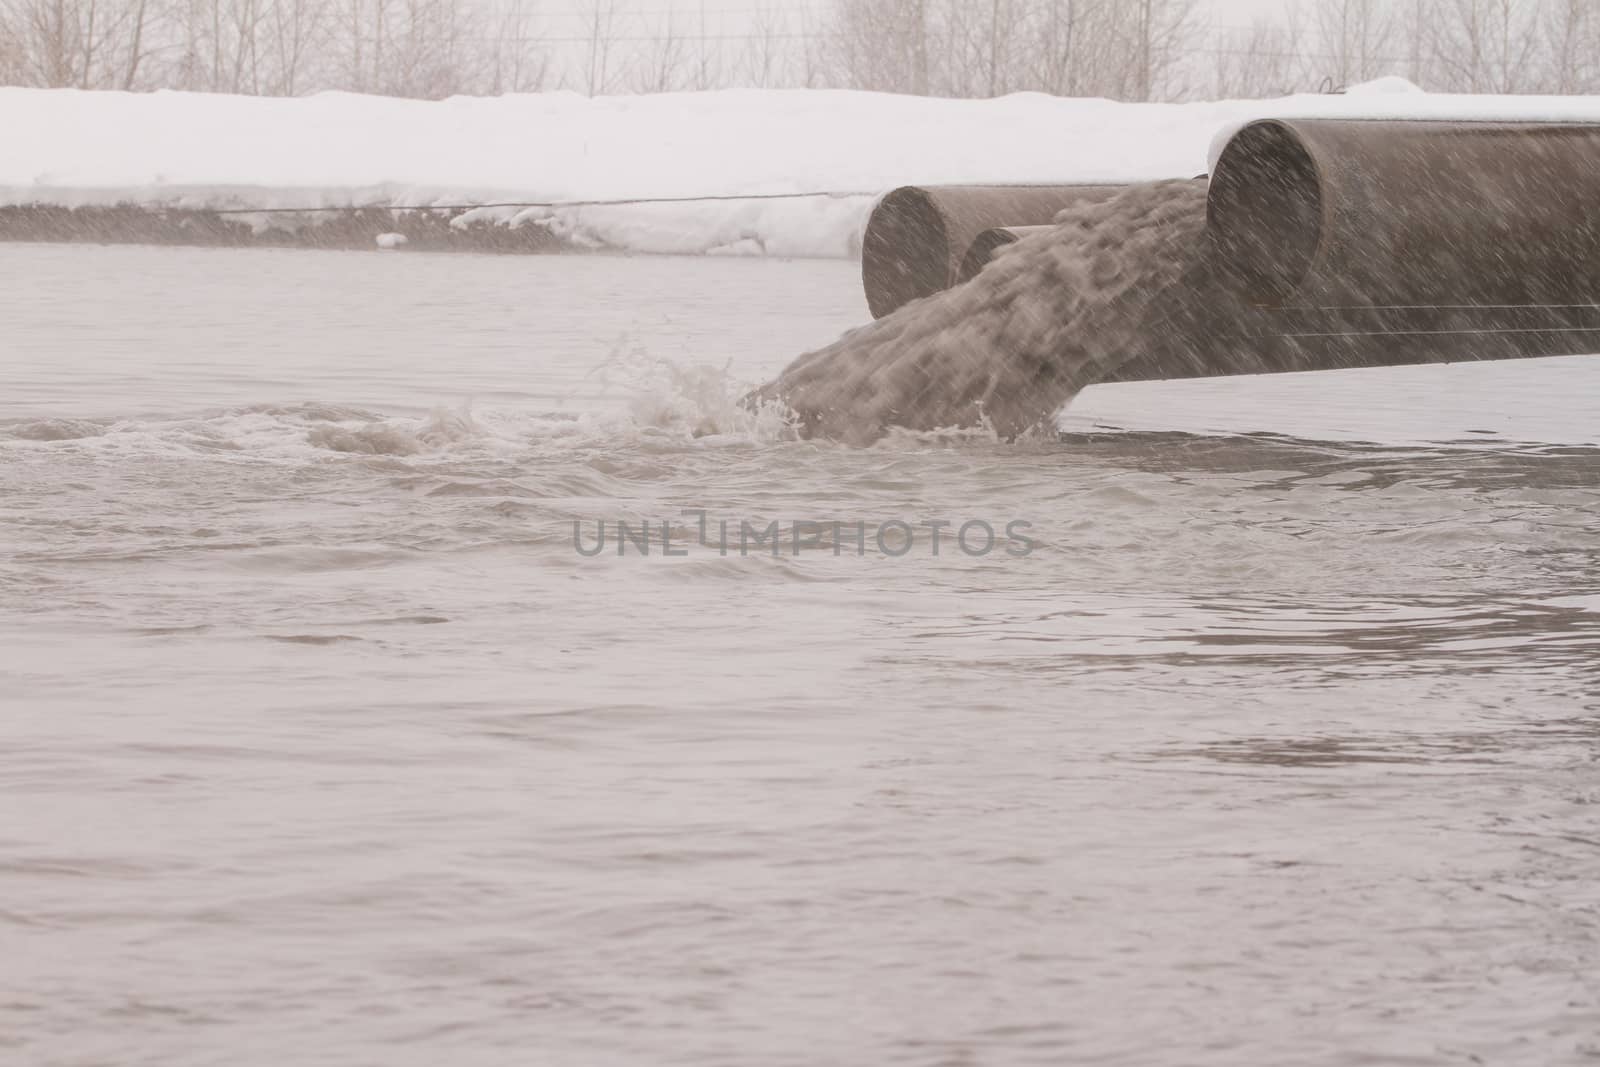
[[861, 186, 1122, 318]]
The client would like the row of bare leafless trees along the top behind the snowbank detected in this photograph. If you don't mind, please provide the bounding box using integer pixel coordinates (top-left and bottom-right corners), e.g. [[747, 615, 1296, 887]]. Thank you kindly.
[[12, 0, 1600, 99]]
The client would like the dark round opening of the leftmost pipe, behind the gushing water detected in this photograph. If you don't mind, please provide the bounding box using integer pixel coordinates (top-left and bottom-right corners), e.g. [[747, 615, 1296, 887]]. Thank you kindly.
[[861, 186, 950, 318]]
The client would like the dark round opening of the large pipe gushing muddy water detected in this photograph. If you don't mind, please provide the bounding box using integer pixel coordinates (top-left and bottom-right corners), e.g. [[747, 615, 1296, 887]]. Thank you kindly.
[[1206, 120, 1322, 304]]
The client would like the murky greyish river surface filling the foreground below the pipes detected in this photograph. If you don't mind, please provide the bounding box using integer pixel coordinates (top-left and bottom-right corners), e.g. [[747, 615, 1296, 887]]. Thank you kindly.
[[0, 245, 1600, 1067]]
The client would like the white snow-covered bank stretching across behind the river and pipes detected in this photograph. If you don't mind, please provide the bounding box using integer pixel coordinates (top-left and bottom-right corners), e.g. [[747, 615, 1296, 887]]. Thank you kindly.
[[9, 78, 1600, 256]]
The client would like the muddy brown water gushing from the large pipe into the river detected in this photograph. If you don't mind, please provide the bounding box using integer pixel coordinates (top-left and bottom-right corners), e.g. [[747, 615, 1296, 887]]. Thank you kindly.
[[760, 181, 1205, 445]]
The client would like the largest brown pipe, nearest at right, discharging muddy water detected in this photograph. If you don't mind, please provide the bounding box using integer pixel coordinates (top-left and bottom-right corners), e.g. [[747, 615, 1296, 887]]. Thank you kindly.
[[1206, 118, 1600, 309]]
